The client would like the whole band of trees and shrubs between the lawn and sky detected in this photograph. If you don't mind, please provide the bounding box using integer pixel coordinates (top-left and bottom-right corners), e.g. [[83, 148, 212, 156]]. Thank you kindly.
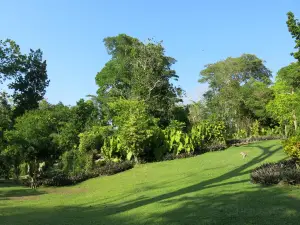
[[0, 13, 300, 187]]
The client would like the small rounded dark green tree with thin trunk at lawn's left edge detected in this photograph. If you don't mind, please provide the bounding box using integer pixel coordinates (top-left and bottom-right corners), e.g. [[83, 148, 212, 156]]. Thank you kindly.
[[5, 104, 68, 187]]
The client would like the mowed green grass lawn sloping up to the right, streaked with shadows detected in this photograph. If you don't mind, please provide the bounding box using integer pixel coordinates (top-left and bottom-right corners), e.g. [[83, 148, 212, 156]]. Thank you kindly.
[[0, 141, 300, 225]]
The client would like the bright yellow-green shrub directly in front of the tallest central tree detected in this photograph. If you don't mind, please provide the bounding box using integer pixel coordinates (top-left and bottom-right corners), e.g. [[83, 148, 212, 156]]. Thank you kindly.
[[109, 99, 159, 163]]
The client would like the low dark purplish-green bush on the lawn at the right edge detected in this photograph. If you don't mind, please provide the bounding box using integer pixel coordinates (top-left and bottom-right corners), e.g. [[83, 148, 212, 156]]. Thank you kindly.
[[251, 160, 300, 185]]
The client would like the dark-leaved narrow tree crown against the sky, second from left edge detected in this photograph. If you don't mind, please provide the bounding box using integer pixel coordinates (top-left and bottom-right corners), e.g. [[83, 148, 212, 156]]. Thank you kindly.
[[8, 49, 50, 117]]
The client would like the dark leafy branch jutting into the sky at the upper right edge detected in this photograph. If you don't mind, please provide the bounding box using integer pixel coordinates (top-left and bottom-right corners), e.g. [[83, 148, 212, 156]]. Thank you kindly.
[[286, 12, 300, 62]]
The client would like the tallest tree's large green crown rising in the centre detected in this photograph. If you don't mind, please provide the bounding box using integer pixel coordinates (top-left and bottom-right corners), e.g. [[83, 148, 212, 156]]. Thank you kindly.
[[96, 34, 182, 125]]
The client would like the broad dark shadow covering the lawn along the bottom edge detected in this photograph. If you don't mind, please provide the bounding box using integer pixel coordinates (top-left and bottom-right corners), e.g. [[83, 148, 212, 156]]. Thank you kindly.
[[0, 188, 300, 225]]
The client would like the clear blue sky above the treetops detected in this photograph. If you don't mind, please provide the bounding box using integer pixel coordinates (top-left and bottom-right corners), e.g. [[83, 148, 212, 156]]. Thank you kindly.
[[0, 0, 300, 104]]
